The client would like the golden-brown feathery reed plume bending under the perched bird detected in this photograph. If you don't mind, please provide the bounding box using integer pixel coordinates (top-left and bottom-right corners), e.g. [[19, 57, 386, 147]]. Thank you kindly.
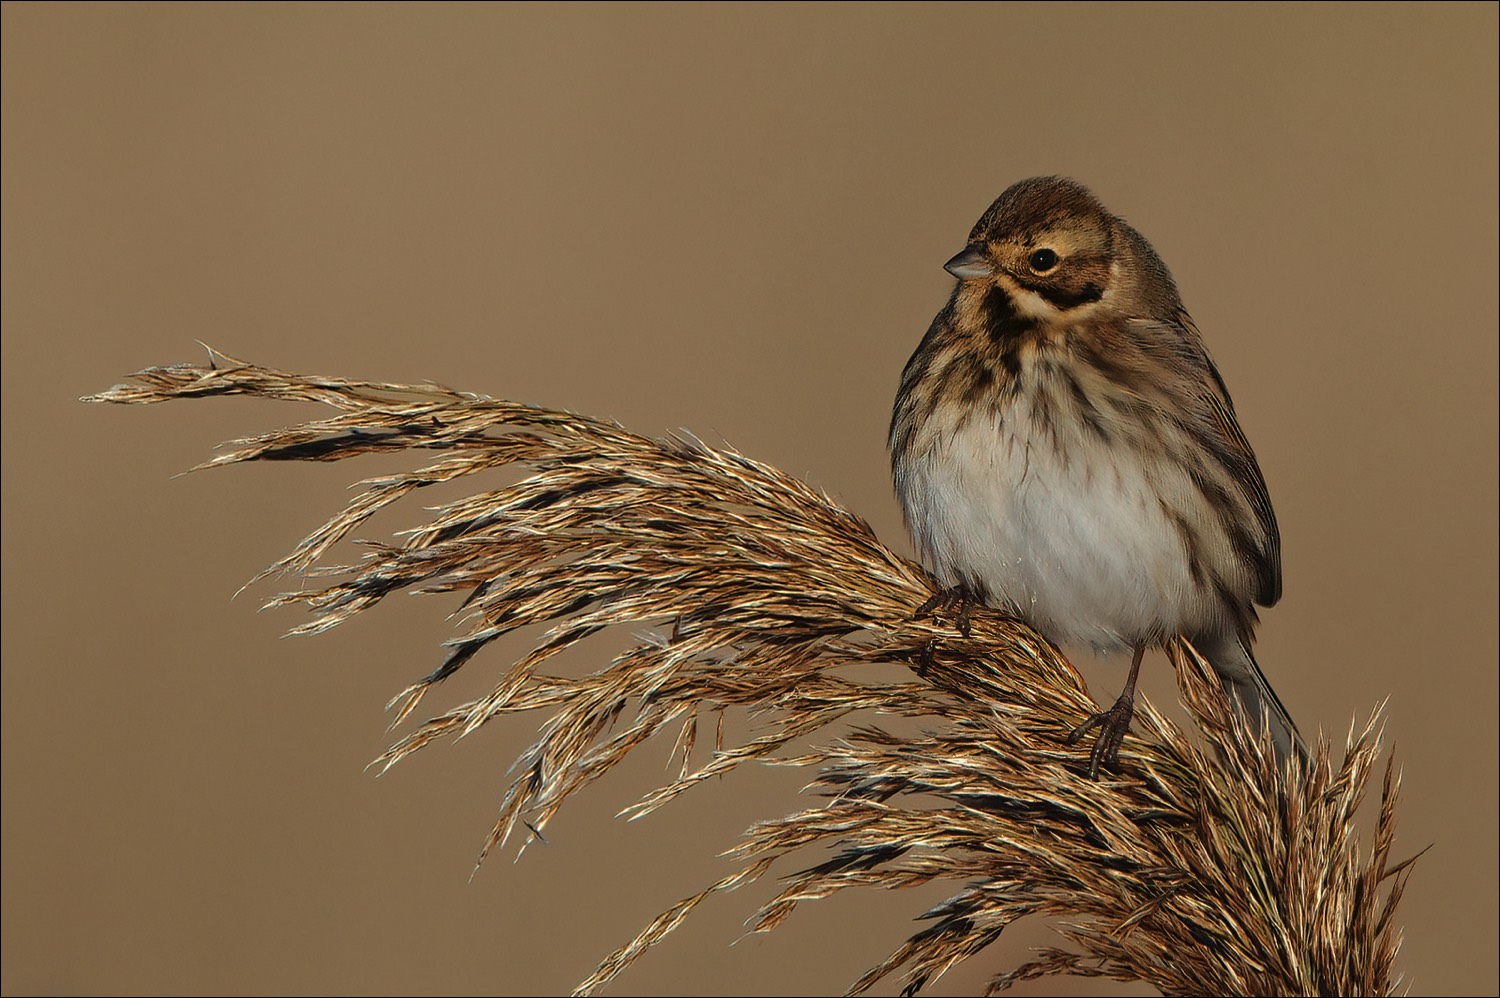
[[87, 354, 1412, 995]]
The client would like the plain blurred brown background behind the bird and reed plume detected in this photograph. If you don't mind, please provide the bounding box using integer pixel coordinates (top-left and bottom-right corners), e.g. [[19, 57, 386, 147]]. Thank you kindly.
[[3, 3, 1500, 995]]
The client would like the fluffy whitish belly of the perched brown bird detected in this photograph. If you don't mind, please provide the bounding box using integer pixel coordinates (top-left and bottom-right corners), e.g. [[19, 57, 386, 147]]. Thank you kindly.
[[897, 402, 1220, 651]]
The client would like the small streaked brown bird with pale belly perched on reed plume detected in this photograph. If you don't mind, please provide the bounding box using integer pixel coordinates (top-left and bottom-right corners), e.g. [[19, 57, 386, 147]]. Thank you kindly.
[[890, 177, 1307, 777]]
